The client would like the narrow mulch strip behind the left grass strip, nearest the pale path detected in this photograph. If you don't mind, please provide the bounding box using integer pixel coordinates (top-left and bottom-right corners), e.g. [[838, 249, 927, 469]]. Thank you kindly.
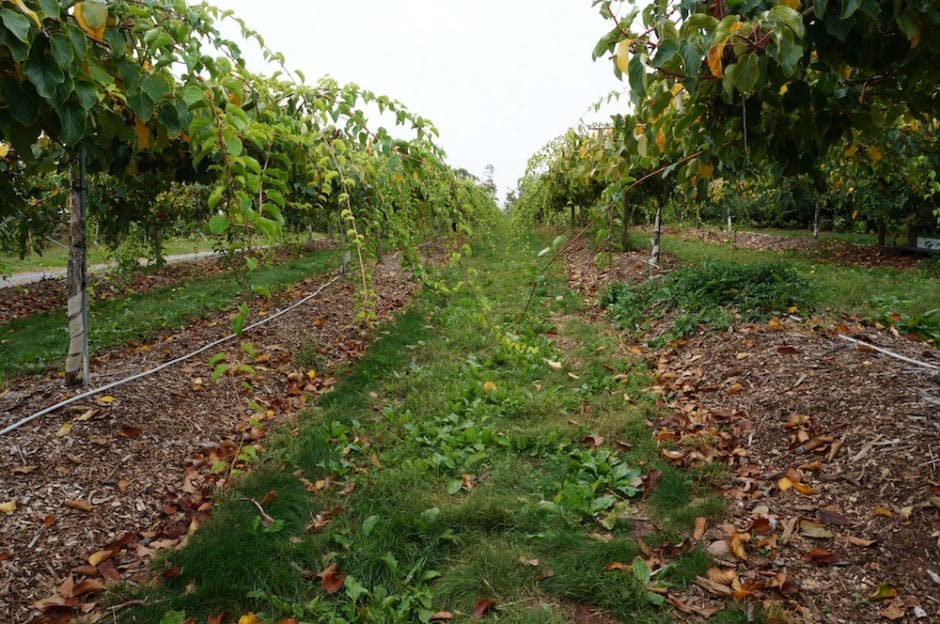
[[0, 241, 334, 325]]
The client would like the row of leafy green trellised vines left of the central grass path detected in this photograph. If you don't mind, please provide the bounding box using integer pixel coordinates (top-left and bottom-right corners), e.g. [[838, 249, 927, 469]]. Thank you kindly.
[[0, 0, 495, 383]]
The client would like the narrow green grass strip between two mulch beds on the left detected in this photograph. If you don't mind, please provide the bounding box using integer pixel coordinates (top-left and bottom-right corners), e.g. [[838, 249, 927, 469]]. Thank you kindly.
[[0, 250, 338, 380]]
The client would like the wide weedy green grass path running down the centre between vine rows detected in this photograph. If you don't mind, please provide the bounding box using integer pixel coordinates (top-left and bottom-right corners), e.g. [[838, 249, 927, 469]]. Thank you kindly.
[[111, 231, 744, 624]]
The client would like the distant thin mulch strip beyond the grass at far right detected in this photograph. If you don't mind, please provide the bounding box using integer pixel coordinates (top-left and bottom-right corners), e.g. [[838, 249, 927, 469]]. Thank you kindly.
[[664, 228, 920, 269]]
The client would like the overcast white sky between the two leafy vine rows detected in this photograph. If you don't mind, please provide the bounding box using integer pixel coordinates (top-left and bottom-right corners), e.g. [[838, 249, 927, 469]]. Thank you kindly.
[[216, 0, 625, 199]]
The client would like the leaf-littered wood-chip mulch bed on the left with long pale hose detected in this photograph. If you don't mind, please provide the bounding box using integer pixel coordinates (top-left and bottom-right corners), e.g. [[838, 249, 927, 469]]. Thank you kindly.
[[0, 249, 426, 622]]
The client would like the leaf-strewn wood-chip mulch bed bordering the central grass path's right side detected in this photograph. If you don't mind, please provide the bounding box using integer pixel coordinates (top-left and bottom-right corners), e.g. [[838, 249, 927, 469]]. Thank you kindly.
[[566, 245, 940, 623]]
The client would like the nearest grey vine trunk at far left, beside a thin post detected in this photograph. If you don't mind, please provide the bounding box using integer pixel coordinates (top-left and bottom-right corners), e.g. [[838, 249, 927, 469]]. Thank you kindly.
[[65, 151, 88, 386]]
